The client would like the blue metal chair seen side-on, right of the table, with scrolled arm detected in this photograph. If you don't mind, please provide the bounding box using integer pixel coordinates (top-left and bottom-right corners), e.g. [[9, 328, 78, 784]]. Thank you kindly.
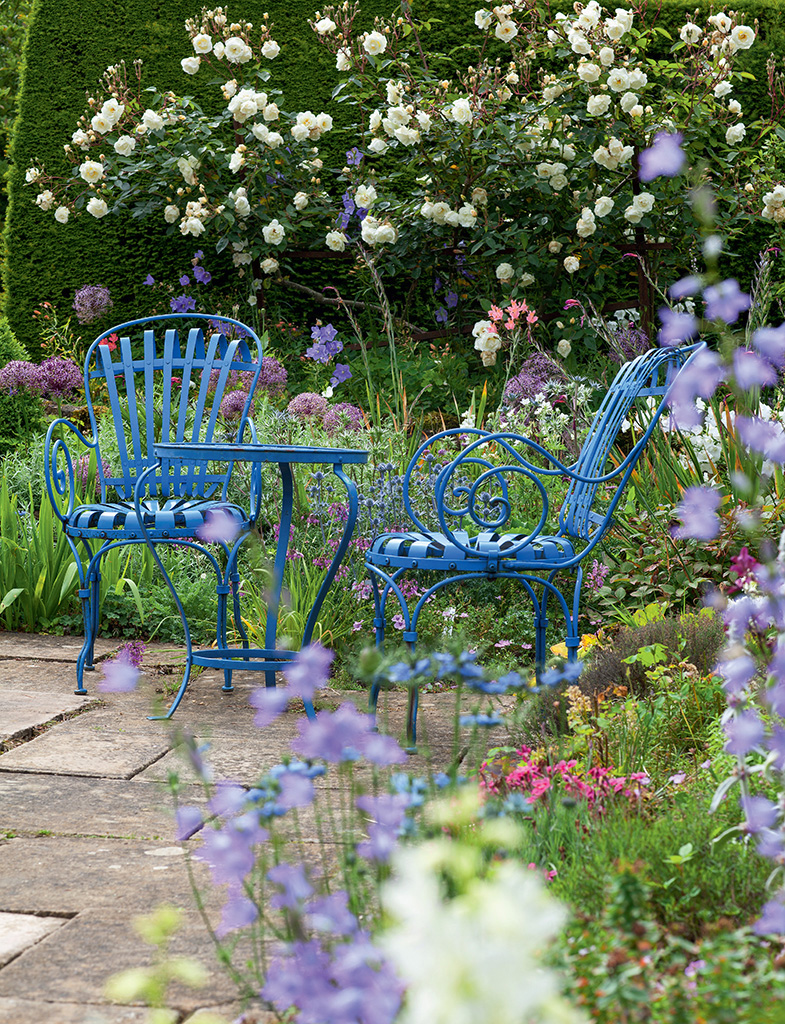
[[365, 342, 705, 742]]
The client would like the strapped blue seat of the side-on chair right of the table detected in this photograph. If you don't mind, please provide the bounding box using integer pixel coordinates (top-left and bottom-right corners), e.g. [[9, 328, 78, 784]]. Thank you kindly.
[[365, 529, 575, 568]]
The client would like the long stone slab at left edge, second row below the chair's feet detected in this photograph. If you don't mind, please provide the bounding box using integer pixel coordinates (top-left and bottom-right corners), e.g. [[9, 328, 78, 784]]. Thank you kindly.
[[0, 772, 205, 841]]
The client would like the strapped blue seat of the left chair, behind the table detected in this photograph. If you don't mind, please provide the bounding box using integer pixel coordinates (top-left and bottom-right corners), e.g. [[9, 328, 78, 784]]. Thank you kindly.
[[64, 498, 251, 539]]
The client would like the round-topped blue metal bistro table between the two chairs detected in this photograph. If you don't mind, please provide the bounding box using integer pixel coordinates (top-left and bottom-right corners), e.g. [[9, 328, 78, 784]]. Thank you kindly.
[[134, 442, 368, 718]]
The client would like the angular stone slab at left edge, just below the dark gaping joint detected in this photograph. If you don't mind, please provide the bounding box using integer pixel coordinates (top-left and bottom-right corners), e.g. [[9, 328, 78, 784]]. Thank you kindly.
[[0, 708, 171, 778]]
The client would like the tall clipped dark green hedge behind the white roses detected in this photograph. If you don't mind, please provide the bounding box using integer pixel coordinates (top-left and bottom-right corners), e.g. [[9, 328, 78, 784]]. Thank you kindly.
[[4, 0, 785, 350]]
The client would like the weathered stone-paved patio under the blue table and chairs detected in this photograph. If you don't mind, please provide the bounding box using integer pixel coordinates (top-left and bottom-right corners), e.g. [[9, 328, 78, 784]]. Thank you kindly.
[[0, 633, 503, 1024]]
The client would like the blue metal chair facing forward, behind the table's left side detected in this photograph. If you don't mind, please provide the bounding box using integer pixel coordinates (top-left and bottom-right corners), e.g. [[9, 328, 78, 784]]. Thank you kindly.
[[45, 313, 262, 718]]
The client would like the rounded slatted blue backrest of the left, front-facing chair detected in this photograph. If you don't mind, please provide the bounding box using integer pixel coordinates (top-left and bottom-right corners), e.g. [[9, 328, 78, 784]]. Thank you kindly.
[[85, 313, 262, 501]]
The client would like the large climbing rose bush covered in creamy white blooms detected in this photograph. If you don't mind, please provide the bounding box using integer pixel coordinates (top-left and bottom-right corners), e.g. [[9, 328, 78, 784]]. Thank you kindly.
[[21, 0, 784, 367]]
